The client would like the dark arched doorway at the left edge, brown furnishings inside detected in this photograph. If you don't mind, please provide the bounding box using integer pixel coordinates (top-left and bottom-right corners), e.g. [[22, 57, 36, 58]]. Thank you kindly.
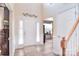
[[0, 4, 9, 56]]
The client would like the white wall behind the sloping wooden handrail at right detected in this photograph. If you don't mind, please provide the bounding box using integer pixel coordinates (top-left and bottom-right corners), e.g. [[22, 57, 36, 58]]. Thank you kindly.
[[53, 8, 77, 55]]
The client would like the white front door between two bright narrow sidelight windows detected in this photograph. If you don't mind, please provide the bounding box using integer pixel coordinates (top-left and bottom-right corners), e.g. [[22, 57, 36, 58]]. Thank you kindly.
[[23, 17, 37, 45]]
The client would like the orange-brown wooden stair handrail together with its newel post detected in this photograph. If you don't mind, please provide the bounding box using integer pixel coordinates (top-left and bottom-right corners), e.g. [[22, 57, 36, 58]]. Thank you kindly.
[[61, 16, 79, 56]]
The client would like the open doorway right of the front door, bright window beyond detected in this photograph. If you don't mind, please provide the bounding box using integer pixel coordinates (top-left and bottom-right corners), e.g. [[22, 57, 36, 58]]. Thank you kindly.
[[43, 18, 53, 44]]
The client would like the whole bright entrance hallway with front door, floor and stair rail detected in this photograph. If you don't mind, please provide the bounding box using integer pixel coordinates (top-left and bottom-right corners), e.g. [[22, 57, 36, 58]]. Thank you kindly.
[[0, 3, 79, 56]]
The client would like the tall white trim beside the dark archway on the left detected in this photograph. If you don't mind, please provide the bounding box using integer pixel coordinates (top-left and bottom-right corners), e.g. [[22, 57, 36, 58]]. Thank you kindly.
[[5, 3, 15, 56]]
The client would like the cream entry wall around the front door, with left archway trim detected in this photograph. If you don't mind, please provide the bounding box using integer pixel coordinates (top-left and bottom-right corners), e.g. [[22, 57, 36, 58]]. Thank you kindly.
[[6, 3, 43, 55]]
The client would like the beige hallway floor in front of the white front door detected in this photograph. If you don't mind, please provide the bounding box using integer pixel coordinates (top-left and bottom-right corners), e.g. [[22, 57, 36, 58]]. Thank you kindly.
[[15, 40, 54, 56]]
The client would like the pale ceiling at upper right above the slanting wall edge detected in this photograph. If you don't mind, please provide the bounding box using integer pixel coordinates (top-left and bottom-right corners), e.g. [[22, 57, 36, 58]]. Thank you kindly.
[[43, 3, 76, 18]]
